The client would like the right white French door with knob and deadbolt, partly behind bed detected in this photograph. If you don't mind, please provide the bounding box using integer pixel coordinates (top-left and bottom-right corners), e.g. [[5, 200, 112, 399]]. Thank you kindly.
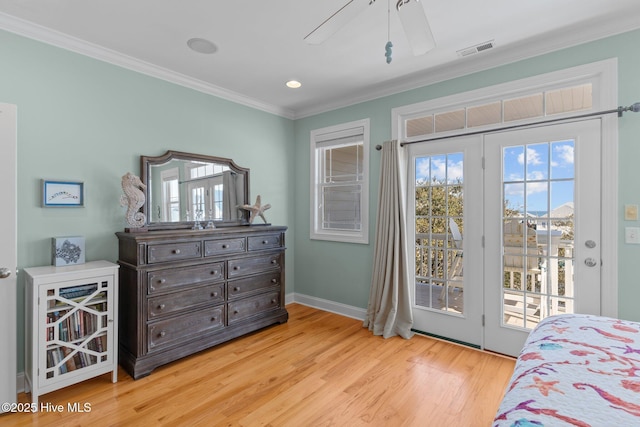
[[484, 119, 601, 356]]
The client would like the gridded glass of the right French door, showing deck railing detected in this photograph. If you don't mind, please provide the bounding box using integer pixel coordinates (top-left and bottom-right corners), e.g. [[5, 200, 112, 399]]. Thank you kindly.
[[502, 141, 575, 329]]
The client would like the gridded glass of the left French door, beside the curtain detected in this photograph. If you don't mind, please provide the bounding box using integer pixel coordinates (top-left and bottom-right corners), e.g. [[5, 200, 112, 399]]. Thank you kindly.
[[415, 153, 464, 314]]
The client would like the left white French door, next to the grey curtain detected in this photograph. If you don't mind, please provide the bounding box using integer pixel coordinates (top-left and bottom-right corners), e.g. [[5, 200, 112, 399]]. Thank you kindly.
[[408, 136, 483, 346]]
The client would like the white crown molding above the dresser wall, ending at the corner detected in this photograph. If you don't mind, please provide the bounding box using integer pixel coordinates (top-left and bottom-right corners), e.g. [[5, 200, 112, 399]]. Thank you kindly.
[[0, 12, 295, 119]]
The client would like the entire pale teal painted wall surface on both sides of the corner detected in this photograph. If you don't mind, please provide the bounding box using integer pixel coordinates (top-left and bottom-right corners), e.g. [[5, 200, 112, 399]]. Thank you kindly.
[[0, 25, 640, 378]]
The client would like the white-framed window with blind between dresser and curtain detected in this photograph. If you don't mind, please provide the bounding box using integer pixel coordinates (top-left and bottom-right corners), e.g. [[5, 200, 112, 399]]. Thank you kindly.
[[310, 119, 369, 244]]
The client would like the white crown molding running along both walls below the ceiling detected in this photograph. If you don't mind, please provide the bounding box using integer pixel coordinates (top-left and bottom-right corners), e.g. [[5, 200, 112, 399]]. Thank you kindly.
[[0, 12, 640, 120]]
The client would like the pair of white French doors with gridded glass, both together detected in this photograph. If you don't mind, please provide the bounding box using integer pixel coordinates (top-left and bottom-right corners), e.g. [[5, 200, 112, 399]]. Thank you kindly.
[[408, 120, 601, 356]]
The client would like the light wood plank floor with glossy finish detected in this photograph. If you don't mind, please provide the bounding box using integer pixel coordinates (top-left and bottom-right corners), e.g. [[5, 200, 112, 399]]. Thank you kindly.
[[0, 304, 514, 427]]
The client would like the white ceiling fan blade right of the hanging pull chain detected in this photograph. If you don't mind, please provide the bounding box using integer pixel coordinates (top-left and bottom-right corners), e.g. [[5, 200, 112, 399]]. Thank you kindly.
[[396, 0, 436, 56]]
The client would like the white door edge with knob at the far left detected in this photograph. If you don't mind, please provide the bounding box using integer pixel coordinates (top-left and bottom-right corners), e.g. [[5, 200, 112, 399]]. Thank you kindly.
[[0, 104, 17, 413]]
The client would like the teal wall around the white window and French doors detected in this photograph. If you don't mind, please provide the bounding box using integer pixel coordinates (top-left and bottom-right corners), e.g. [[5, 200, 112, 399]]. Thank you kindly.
[[294, 31, 640, 320]]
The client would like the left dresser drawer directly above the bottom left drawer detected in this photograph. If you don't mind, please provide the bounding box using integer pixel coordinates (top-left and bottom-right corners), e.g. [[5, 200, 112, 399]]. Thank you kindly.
[[147, 283, 224, 320]]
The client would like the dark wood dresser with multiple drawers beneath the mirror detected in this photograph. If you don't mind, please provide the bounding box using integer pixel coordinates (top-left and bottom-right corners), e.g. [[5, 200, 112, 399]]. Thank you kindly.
[[116, 225, 289, 379]]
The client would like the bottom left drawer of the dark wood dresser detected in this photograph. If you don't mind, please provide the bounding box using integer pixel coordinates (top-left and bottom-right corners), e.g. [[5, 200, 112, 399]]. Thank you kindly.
[[147, 306, 224, 351]]
